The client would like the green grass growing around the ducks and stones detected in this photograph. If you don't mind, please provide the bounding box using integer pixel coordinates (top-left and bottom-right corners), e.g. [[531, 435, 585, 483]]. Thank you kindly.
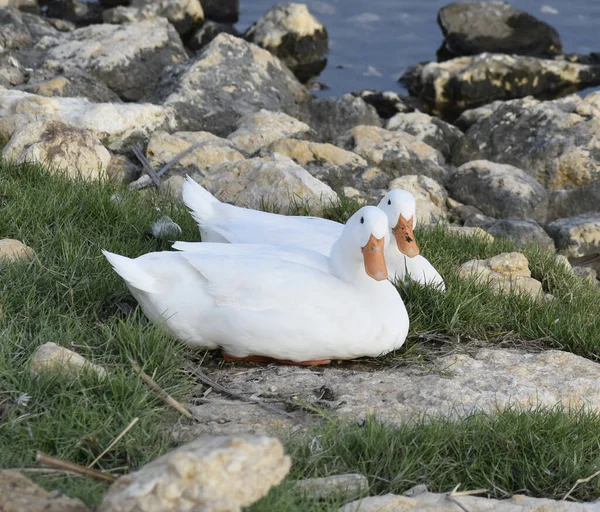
[[0, 162, 600, 510]]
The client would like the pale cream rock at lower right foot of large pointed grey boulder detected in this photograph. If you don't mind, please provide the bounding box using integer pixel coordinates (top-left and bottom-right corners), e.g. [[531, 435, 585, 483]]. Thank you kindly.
[[227, 109, 311, 154]]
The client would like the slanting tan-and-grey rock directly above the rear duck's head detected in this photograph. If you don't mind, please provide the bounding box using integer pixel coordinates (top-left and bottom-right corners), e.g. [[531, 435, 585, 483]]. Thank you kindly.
[[336, 126, 447, 182]]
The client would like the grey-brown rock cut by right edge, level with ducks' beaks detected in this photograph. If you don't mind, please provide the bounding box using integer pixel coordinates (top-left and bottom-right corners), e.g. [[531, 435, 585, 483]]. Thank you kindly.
[[546, 213, 600, 258]]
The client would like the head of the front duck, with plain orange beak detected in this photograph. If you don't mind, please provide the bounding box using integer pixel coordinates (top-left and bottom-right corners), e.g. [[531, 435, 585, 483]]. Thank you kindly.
[[340, 206, 389, 281]]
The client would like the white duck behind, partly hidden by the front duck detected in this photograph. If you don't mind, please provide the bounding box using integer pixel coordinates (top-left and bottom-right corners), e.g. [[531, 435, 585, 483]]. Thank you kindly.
[[176, 177, 446, 291]]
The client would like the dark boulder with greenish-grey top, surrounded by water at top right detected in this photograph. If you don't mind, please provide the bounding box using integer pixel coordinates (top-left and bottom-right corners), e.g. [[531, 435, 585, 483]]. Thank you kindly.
[[438, 2, 562, 58]]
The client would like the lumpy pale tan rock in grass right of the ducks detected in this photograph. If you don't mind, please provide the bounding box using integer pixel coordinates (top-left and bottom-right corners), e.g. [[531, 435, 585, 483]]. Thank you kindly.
[[458, 252, 544, 299]]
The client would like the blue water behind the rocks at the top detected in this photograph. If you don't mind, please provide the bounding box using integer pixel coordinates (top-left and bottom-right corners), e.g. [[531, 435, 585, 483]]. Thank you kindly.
[[237, 0, 600, 96]]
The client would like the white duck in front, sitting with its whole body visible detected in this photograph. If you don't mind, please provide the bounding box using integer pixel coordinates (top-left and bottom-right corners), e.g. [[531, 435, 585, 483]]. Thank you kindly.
[[104, 206, 409, 365]]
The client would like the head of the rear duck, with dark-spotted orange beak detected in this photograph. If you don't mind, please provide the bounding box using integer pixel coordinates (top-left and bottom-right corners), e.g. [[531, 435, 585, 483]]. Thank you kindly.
[[377, 188, 419, 258]]
